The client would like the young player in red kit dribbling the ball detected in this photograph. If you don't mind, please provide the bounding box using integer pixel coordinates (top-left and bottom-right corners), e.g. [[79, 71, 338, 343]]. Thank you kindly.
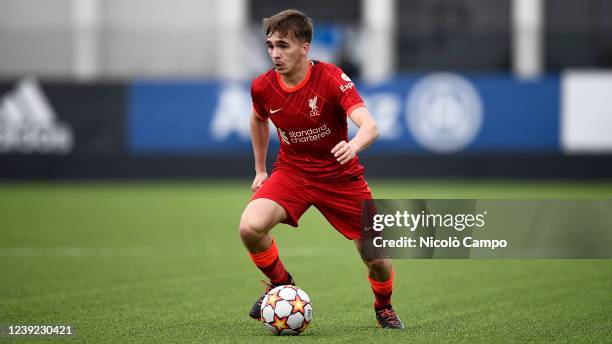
[[240, 10, 404, 329]]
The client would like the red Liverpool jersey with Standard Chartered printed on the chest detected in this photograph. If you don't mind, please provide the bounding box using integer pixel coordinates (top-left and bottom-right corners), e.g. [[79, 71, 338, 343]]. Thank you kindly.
[[251, 61, 365, 180]]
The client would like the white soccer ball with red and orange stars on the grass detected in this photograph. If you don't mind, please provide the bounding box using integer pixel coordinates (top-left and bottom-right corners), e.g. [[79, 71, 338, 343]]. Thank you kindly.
[[261, 285, 312, 336]]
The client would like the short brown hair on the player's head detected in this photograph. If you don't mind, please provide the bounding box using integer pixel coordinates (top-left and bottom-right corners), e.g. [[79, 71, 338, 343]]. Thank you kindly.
[[263, 10, 312, 43]]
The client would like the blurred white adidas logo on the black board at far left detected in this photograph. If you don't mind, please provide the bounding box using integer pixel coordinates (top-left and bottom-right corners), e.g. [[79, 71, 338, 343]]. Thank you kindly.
[[0, 78, 74, 154]]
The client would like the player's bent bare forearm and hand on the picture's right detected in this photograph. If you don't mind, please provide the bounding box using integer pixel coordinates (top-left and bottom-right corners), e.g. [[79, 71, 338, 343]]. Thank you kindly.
[[331, 106, 378, 165]]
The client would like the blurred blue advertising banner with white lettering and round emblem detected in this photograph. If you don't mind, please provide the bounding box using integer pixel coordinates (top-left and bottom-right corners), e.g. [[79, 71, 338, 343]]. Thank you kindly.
[[128, 73, 560, 155]]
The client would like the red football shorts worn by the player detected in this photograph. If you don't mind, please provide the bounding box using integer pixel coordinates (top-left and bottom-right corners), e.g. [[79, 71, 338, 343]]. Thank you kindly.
[[251, 168, 372, 240]]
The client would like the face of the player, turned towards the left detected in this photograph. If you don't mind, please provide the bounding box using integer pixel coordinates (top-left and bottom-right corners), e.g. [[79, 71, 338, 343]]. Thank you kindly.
[[266, 32, 310, 75]]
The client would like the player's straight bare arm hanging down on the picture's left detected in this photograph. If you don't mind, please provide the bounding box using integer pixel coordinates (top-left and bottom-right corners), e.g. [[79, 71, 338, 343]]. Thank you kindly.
[[251, 109, 270, 191]]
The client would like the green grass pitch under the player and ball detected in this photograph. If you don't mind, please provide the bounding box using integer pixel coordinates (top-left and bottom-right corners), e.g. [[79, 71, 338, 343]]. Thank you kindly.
[[0, 180, 612, 343]]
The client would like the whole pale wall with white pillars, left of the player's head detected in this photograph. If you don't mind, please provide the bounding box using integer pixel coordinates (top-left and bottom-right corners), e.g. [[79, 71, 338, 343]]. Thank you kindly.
[[0, 0, 247, 78]]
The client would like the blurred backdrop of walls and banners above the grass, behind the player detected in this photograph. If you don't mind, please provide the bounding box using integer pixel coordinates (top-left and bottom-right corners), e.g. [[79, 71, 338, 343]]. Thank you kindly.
[[0, 0, 612, 180]]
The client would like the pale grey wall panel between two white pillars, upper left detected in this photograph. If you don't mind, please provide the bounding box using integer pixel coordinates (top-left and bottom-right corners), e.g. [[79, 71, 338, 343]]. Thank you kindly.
[[100, 0, 214, 77]]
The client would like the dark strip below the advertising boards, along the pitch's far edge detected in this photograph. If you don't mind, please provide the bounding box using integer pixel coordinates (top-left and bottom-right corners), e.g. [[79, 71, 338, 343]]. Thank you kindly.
[[0, 154, 612, 181]]
